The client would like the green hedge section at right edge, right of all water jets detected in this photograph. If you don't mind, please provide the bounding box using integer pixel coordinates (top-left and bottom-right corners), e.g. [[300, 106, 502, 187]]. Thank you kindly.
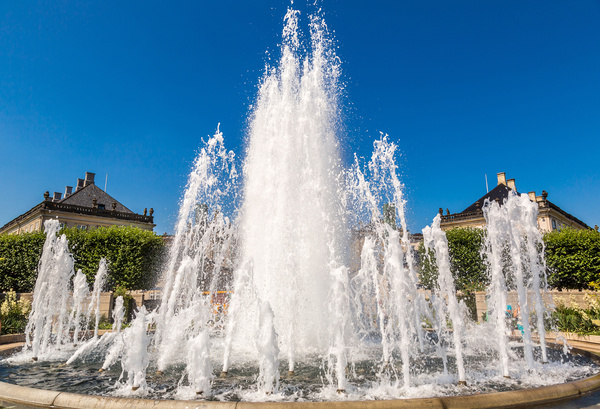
[[544, 228, 600, 290]]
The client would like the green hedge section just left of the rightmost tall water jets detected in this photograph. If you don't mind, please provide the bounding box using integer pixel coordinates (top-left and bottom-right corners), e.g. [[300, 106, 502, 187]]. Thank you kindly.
[[419, 228, 489, 294]]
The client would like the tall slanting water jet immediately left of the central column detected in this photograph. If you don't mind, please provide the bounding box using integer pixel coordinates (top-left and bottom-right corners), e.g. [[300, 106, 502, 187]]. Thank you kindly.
[[154, 125, 237, 372]]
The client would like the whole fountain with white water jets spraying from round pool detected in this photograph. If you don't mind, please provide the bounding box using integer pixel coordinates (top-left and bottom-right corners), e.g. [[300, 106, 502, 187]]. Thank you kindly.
[[0, 3, 598, 407]]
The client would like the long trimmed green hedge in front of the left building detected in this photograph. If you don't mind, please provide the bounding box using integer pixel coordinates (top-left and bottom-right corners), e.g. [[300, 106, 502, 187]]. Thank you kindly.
[[0, 226, 165, 292]]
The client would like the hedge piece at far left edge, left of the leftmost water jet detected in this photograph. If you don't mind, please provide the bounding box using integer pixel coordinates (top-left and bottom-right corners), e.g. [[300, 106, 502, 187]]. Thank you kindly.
[[0, 232, 46, 293]]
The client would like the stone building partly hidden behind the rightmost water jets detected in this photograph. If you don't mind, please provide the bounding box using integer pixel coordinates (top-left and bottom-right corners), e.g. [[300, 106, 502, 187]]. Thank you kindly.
[[439, 172, 590, 233]]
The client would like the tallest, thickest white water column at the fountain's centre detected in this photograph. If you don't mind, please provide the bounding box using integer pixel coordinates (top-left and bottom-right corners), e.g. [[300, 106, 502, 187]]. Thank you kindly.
[[224, 9, 345, 371]]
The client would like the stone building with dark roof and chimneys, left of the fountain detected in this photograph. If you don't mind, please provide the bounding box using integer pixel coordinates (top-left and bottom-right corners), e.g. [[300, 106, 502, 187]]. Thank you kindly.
[[0, 172, 156, 234]]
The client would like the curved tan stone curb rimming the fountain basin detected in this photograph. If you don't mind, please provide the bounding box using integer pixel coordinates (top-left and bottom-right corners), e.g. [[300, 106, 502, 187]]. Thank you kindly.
[[0, 344, 600, 409]]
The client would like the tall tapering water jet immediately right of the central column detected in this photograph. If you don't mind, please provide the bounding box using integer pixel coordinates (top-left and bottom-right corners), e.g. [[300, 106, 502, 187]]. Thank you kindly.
[[349, 135, 427, 388]]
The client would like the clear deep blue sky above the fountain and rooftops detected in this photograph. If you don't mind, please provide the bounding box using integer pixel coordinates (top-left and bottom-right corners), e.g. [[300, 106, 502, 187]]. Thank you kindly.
[[0, 0, 600, 234]]
